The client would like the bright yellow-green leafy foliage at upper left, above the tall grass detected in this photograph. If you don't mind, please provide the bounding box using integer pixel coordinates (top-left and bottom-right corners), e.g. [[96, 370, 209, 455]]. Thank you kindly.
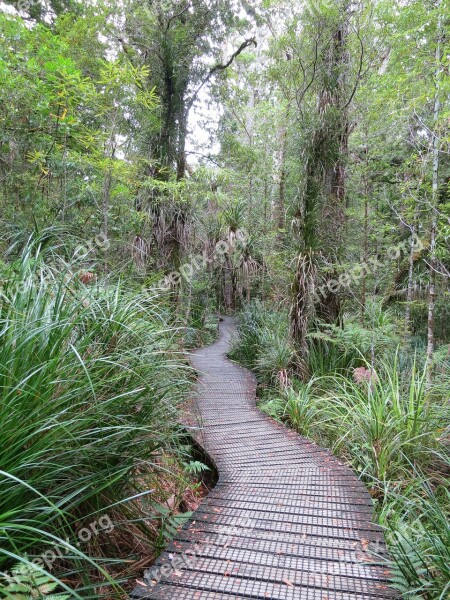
[[0, 7, 157, 264]]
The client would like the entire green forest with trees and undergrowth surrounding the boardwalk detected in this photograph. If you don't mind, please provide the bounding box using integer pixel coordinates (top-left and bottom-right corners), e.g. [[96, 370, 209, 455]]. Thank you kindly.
[[0, 0, 450, 600]]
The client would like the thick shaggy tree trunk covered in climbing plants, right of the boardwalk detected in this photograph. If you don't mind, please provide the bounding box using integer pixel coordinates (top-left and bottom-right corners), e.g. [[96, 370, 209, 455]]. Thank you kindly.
[[291, 1, 363, 353]]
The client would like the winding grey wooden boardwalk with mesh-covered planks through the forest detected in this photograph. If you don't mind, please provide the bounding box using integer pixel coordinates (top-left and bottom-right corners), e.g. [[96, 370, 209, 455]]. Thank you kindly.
[[132, 318, 395, 600]]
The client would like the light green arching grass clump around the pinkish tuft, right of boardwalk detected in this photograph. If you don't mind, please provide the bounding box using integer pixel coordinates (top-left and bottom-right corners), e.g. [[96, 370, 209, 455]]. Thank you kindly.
[[316, 359, 445, 488]]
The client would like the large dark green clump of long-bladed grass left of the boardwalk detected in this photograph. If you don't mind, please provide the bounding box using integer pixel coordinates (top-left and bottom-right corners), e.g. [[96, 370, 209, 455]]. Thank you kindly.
[[0, 243, 187, 598]]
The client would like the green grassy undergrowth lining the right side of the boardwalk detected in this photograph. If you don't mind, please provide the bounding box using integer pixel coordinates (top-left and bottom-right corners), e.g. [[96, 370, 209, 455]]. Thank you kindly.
[[236, 303, 450, 600]]
